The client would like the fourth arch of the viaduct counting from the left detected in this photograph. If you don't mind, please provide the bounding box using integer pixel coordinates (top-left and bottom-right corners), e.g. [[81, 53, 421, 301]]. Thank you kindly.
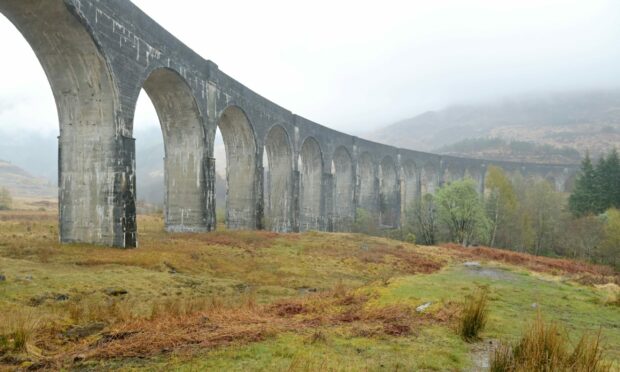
[[265, 125, 293, 232]]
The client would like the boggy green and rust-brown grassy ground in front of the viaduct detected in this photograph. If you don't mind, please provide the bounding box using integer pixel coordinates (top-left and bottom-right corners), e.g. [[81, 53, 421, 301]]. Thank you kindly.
[[0, 211, 620, 371]]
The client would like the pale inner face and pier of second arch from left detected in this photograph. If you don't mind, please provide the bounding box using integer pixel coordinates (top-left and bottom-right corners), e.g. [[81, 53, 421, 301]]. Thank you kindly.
[[138, 68, 208, 232]]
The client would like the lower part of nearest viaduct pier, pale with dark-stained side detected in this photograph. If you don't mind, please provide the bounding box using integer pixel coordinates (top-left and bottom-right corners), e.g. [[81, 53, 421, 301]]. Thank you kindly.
[[58, 133, 137, 247]]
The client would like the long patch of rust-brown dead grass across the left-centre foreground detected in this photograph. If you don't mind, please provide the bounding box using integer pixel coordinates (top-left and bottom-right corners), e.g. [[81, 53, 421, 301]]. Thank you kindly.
[[36, 289, 456, 367]]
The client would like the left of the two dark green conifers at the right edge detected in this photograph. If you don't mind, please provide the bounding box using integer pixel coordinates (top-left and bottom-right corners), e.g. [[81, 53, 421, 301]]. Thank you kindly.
[[568, 154, 599, 217]]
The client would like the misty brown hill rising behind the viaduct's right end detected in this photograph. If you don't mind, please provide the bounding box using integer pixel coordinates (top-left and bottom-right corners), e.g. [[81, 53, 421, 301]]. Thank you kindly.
[[366, 90, 620, 162]]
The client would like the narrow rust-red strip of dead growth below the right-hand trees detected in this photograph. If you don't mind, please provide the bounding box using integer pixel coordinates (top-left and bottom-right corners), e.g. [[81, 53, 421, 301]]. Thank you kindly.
[[442, 244, 620, 285]]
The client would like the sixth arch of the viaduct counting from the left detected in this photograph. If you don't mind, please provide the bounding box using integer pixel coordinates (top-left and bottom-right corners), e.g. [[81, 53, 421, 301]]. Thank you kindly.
[[332, 146, 355, 231]]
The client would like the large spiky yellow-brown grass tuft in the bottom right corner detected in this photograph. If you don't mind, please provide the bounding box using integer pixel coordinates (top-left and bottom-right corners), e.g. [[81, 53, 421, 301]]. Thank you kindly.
[[490, 315, 611, 372]]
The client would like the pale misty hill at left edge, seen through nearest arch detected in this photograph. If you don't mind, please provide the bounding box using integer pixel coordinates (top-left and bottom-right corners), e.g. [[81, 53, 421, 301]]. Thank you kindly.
[[0, 160, 58, 197]]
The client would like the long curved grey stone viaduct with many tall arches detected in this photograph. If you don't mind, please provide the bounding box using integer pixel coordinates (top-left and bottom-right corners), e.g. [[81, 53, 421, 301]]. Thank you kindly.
[[0, 0, 576, 247]]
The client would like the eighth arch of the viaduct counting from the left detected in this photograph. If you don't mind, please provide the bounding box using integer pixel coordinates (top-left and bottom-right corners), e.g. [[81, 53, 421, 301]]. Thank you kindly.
[[379, 156, 400, 227]]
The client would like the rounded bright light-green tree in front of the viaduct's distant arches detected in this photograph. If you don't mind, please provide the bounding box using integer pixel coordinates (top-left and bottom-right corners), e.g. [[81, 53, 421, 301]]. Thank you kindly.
[[436, 179, 489, 246]]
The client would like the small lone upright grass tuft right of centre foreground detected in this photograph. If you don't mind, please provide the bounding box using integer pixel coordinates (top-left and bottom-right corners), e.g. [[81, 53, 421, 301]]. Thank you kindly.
[[458, 289, 489, 342]]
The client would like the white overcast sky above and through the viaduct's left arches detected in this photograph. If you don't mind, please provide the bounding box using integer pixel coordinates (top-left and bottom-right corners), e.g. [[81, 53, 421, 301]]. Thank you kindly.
[[0, 0, 620, 134]]
